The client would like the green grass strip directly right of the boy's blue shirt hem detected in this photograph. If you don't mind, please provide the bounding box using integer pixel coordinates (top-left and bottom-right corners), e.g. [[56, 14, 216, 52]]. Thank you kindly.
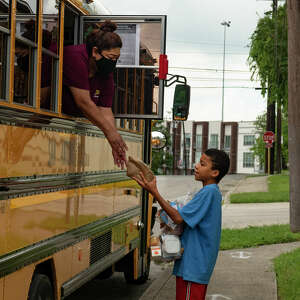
[[220, 225, 300, 250]]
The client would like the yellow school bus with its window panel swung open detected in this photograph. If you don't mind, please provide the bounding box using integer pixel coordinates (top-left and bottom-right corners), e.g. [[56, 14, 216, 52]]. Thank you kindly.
[[0, 0, 166, 300]]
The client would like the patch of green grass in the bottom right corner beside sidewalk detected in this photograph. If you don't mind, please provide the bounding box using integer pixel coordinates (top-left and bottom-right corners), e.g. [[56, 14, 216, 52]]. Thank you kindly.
[[274, 248, 300, 300]]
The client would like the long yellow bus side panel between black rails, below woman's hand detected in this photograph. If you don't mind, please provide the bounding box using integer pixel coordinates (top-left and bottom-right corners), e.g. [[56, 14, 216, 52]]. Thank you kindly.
[[0, 181, 140, 256]]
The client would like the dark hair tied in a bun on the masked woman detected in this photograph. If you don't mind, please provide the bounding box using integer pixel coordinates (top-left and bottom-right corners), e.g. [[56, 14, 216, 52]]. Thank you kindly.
[[86, 21, 122, 57]]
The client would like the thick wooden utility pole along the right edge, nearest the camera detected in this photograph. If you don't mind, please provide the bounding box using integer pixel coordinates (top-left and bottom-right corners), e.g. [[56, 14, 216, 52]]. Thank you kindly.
[[287, 0, 300, 232]]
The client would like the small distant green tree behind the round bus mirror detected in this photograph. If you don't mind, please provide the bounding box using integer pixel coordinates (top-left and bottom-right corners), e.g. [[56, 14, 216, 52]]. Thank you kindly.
[[151, 121, 173, 175]]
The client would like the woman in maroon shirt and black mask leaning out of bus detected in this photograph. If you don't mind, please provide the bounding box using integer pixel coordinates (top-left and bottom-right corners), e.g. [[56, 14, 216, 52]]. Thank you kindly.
[[62, 21, 128, 169]]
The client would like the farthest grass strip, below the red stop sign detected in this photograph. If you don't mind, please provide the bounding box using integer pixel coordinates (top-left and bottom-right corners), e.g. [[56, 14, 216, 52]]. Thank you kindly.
[[230, 175, 290, 203]]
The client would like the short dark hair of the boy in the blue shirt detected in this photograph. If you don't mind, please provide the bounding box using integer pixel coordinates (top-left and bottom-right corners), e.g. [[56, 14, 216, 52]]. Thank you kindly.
[[204, 149, 230, 183]]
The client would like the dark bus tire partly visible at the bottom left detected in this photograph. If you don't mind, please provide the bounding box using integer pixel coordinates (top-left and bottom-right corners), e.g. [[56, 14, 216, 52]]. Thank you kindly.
[[28, 274, 54, 300]]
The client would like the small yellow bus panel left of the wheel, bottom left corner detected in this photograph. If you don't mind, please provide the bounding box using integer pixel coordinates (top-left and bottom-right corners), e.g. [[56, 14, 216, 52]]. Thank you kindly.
[[4, 265, 34, 300]]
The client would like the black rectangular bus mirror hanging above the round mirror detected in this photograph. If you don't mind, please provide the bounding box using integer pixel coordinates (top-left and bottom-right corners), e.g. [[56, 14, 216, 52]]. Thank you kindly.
[[173, 84, 191, 121]]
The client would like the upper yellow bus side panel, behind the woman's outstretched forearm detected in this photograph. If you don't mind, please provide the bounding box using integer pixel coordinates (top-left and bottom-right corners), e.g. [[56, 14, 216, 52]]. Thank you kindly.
[[0, 125, 142, 178]]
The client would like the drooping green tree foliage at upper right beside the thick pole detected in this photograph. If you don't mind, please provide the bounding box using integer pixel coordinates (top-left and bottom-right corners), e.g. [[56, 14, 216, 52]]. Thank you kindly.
[[248, 5, 288, 113]]
